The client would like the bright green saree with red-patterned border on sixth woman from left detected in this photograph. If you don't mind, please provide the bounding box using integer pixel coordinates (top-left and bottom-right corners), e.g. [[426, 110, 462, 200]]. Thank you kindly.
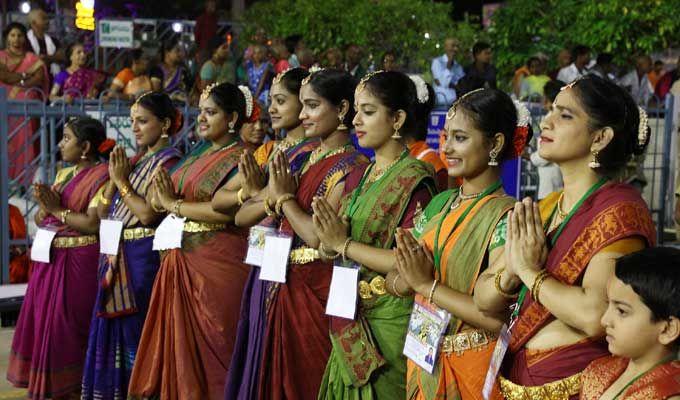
[[318, 157, 435, 400]]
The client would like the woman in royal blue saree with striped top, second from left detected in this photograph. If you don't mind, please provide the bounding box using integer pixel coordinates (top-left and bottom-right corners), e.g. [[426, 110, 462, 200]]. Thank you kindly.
[[81, 93, 182, 400]]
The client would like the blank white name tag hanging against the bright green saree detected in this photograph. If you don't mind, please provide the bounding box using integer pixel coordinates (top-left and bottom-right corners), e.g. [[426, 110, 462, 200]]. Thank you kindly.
[[326, 260, 359, 319]]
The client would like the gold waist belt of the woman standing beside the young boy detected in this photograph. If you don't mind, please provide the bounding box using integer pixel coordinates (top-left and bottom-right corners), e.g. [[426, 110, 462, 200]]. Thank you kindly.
[[498, 372, 581, 400]]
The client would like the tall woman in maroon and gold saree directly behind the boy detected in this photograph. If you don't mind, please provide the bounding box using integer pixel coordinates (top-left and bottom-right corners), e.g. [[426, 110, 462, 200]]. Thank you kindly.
[[475, 76, 656, 400]]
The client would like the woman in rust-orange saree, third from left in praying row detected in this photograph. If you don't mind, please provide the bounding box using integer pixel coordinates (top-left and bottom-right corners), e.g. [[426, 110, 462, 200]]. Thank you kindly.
[[129, 83, 250, 400]]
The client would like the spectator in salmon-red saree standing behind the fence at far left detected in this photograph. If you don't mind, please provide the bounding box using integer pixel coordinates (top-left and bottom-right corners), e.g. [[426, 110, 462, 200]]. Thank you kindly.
[[0, 22, 49, 183]]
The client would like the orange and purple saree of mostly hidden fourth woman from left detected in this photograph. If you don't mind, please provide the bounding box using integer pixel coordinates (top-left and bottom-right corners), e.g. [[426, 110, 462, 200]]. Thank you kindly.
[[224, 140, 319, 400]]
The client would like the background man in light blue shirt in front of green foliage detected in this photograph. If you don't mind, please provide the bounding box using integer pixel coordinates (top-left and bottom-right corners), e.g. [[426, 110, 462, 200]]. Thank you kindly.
[[432, 38, 465, 107]]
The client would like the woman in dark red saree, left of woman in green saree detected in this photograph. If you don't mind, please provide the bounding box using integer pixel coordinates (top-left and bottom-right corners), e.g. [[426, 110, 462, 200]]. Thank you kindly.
[[238, 70, 366, 399]]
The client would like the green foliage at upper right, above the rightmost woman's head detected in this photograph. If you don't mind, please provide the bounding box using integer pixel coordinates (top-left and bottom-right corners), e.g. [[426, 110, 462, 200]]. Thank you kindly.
[[489, 0, 680, 80]]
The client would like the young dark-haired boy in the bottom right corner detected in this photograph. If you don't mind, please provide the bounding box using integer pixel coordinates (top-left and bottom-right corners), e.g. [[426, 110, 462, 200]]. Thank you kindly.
[[580, 247, 680, 400]]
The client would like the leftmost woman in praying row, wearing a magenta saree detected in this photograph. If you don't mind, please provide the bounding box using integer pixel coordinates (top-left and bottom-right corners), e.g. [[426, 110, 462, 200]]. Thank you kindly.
[[7, 118, 108, 399]]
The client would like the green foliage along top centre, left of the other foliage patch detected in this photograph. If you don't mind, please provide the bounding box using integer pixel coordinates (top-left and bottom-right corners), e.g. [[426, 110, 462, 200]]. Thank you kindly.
[[239, 0, 482, 70]]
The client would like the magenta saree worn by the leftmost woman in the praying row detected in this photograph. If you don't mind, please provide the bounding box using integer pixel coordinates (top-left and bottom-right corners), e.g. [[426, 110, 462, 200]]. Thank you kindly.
[[7, 165, 108, 399]]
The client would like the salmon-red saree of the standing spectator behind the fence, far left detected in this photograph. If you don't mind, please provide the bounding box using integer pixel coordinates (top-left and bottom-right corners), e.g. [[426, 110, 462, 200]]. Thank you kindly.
[[0, 50, 49, 184]]
